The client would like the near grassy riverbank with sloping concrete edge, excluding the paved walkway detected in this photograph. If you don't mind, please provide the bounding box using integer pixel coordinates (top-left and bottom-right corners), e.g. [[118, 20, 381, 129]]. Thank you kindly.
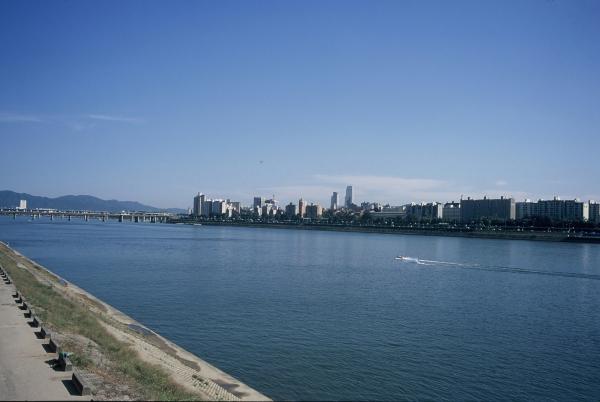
[[0, 242, 268, 400]]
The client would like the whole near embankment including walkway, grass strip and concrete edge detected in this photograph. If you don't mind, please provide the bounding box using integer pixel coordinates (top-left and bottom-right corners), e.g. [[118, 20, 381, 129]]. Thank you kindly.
[[0, 242, 268, 400]]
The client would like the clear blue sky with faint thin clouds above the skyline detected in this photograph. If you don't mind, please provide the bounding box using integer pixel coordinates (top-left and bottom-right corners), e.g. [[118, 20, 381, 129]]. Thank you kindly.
[[0, 0, 600, 207]]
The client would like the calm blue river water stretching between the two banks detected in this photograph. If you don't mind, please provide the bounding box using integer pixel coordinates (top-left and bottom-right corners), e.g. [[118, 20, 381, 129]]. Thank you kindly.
[[0, 218, 600, 400]]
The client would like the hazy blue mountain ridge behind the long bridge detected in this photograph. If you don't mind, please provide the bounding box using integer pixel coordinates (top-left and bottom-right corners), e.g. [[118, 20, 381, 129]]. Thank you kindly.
[[0, 190, 186, 213]]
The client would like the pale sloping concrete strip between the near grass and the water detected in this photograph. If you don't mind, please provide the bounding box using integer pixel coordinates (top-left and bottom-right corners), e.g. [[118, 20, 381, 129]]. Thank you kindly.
[[0, 241, 270, 401]]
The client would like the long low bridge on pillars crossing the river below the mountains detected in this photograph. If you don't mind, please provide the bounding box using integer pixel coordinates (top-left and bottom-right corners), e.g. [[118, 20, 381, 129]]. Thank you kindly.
[[0, 209, 173, 223]]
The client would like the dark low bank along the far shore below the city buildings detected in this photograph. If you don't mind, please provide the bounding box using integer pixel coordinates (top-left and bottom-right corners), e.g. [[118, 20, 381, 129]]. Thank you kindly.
[[171, 221, 600, 244]]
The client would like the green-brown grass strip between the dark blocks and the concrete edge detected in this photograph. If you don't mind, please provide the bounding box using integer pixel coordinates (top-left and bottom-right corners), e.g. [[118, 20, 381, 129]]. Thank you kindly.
[[0, 250, 199, 400]]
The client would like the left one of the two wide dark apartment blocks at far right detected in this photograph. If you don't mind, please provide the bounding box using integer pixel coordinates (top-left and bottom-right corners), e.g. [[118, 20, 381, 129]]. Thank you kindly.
[[460, 197, 516, 222]]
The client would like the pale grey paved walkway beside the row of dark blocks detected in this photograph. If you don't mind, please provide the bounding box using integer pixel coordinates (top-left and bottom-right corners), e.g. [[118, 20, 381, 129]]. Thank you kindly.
[[0, 281, 89, 401]]
